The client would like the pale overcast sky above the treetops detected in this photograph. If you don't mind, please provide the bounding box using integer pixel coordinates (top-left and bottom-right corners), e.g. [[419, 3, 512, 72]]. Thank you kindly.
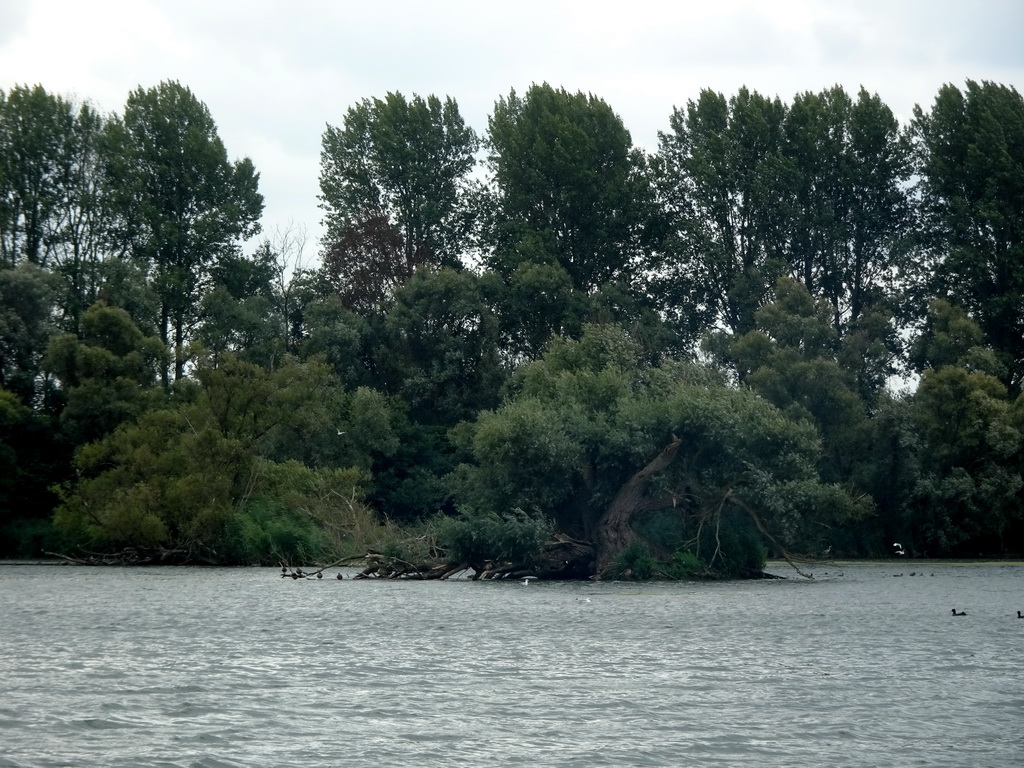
[[0, 0, 1024, 250]]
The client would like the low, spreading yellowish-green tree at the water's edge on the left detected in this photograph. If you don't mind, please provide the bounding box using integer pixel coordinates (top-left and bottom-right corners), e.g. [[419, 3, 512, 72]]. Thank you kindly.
[[56, 355, 366, 562]]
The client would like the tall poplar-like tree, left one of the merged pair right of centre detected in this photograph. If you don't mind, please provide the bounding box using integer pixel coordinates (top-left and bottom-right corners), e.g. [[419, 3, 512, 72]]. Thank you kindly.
[[657, 88, 793, 335]]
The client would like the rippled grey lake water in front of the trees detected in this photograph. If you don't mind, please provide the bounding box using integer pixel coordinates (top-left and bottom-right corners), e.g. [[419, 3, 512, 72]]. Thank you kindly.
[[0, 563, 1024, 768]]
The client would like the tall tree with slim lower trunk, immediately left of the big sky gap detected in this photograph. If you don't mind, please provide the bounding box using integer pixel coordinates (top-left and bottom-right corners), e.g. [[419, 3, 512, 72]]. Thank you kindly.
[[109, 82, 263, 385]]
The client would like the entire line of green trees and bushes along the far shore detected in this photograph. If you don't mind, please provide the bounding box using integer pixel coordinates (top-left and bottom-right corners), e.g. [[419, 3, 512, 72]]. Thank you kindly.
[[0, 81, 1024, 574]]
